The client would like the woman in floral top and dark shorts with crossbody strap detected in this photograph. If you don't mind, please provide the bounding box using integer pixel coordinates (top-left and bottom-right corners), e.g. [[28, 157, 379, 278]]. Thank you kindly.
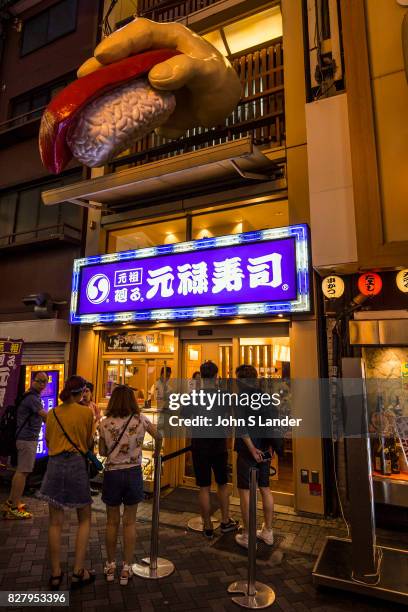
[[99, 385, 161, 585]]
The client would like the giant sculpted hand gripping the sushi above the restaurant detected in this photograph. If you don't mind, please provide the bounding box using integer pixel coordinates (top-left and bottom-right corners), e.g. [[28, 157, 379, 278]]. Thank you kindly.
[[78, 18, 241, 138]]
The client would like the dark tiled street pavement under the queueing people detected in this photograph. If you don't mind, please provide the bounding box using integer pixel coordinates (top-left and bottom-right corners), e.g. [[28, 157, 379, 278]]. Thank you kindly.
[[0, 494, 407, 612]]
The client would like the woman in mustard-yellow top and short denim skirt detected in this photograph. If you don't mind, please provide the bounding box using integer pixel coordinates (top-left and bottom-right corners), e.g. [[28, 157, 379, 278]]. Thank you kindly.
[[38, 376, 95, 590]]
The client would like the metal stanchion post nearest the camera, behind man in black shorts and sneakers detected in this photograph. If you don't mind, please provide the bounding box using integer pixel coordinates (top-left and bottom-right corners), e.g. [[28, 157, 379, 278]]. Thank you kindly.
[[228, 467, 275, 610]]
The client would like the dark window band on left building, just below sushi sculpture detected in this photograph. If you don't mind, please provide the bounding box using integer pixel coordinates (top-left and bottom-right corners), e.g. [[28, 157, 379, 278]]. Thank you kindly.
[[0, 171, 82, 246]]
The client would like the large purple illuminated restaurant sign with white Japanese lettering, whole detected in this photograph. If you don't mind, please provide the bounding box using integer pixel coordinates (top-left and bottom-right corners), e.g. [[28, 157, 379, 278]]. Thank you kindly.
[[71, 225, 311, 324]]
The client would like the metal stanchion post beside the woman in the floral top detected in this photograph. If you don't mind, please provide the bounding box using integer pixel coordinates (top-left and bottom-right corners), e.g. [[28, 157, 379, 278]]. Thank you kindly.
[[132, 455, 174, 579]]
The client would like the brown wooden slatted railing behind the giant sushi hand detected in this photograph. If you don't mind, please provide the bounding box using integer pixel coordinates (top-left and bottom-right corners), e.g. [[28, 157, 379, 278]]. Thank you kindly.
[[110, 39, 285, 170]]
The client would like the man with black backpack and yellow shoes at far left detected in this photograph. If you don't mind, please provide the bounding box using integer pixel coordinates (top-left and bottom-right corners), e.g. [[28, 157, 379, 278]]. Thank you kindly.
[[2, 372, 48, 519]]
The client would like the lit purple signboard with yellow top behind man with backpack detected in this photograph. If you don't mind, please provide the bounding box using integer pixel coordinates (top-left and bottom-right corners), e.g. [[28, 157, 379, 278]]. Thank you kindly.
[[26, 363, 64, 459]]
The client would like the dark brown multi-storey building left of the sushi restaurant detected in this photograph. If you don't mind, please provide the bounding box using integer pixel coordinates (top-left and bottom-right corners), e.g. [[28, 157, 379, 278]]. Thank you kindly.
[[0, 0, 100, 385]]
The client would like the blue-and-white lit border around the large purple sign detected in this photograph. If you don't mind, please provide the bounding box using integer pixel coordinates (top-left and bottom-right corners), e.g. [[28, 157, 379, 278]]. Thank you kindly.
[[70, 224, 311, 325]]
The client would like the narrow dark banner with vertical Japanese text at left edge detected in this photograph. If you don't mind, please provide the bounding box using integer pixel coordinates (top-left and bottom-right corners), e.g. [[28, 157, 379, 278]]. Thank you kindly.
[[0, 338, 24, 417]]
